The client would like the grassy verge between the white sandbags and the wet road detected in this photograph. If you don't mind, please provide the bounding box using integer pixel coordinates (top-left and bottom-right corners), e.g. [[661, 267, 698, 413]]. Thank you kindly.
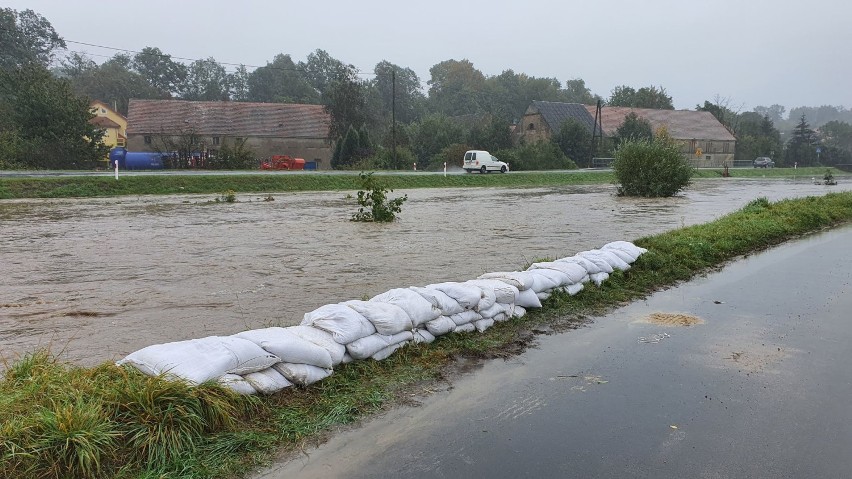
[[5, 192, 852, 478]]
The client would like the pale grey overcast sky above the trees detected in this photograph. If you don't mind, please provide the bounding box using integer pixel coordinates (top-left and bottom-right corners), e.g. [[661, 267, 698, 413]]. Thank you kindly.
[[8, 0, 852, 115]]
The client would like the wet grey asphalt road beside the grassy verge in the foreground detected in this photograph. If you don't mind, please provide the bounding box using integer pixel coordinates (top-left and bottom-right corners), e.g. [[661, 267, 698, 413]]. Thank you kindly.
[[255, 227, 852, 479]]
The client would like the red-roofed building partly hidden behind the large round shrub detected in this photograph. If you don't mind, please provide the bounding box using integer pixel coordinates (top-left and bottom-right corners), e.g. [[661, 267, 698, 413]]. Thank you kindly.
[[586, 105, 737, 168]]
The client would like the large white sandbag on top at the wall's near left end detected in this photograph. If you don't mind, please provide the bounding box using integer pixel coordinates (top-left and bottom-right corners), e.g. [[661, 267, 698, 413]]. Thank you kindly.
[[116, 336, 280, 384]]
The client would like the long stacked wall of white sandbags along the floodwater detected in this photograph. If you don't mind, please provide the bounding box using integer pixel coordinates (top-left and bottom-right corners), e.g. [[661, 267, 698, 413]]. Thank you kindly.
[[116, 241, 647, 394]]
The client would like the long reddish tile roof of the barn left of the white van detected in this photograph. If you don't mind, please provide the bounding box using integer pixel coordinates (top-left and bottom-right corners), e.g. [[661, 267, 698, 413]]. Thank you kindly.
[[127, 100, 331, 138]]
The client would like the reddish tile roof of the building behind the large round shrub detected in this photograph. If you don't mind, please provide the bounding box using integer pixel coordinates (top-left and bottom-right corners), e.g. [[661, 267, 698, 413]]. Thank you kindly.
[[586, 105, 736, 141]]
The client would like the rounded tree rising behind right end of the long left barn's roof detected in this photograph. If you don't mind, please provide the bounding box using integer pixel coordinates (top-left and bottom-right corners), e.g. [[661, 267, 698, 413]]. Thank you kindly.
[[248, 54, 320, 103]]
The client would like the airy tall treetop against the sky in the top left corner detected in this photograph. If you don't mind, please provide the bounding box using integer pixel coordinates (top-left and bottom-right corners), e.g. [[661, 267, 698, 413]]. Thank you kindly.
[[0, 8, 65, 70]]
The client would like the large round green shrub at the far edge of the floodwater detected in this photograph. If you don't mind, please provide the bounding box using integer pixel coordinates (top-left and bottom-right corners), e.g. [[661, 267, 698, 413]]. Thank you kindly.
[[612, 136, 693, 197]]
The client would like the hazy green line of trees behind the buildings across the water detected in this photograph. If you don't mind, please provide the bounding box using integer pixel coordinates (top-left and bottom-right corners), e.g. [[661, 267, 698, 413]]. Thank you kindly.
[[0, 8, 849, 169]]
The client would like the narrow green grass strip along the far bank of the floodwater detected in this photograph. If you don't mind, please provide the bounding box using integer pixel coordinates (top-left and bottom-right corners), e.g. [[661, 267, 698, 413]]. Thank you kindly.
[[0, 168, 846, 199]]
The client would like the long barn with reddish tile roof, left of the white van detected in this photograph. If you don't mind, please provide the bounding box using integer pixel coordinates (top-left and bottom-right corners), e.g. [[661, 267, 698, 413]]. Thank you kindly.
[[127, 100, 333, 169]]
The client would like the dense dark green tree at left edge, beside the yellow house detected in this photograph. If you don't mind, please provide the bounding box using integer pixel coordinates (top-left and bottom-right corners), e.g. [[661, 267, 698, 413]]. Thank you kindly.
[[0, 63, 106, 168]]
